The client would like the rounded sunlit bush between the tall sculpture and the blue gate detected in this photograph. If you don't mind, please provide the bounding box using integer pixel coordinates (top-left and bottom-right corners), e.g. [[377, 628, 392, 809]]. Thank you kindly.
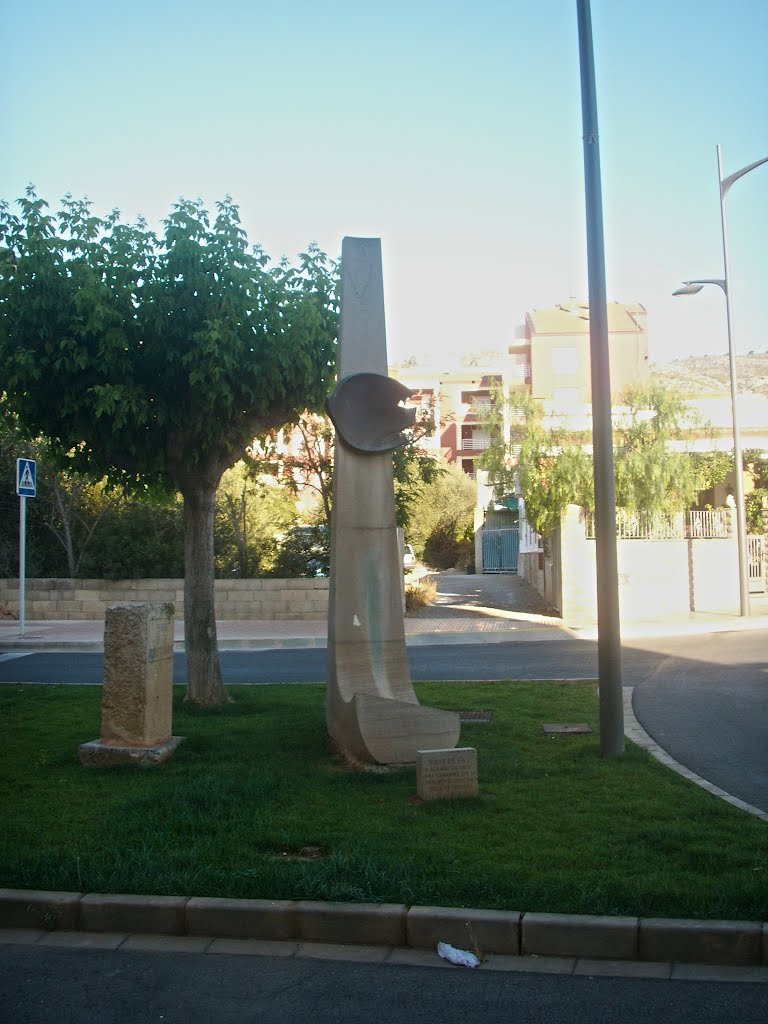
[[408, 465, 477, 568]]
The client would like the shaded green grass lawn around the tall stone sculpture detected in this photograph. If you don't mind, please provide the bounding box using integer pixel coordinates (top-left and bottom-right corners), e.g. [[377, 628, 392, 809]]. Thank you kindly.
[[0, 682, 768, 921]]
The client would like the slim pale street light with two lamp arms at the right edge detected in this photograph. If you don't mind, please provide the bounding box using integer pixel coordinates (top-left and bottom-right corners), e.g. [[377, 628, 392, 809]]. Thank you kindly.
[[673, 145, 768, 616]]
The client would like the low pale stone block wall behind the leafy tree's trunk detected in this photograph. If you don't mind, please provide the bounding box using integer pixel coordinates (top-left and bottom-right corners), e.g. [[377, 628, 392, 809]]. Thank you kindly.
[[0, 579, 328, 621]]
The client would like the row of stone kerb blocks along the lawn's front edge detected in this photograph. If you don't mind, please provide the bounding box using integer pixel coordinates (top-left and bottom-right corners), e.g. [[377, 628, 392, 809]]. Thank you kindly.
[[0, 889, 768, 967]]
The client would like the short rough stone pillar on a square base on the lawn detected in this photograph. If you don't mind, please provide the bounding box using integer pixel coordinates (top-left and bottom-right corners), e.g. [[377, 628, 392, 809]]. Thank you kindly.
[[79, 602, 181, 767]]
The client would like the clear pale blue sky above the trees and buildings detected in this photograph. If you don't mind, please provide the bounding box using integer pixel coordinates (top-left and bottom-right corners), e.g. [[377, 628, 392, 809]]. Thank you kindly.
[[0, 0, 768, 362]]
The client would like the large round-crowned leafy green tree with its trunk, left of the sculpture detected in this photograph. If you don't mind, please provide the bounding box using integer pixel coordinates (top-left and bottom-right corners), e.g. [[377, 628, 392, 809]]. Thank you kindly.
[[0, 187, 337, 705]]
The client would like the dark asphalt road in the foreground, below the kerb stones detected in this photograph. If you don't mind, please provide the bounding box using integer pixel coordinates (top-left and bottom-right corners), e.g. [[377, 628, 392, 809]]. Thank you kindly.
[[0, 946, 768, 1024]]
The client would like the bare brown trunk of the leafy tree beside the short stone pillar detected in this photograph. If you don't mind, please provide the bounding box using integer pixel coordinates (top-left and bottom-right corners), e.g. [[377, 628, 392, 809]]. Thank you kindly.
[[181, 478, 229, 707]]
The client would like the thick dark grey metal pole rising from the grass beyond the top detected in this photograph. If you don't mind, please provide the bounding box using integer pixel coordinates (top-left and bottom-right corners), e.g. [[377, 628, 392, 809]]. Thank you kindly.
[[577, 0, 624, 757]]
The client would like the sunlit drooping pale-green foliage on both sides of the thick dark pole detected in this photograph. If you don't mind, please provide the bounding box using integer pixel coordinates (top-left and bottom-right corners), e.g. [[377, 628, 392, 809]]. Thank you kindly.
[[481, 384, 729, 537]]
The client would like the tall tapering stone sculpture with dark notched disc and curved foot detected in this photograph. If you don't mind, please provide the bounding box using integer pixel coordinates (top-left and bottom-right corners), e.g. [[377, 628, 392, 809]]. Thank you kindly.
[[326, 239, 460, 764]]
